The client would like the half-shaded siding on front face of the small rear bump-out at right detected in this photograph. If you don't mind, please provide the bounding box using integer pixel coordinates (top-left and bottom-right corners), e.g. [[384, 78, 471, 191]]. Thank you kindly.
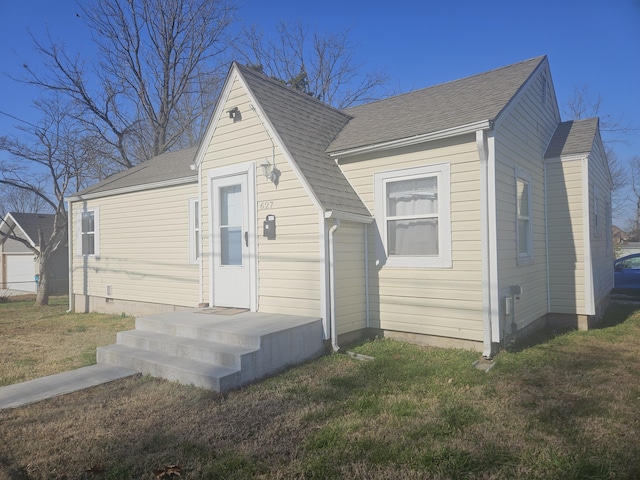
[[547, 159, 585, 314]]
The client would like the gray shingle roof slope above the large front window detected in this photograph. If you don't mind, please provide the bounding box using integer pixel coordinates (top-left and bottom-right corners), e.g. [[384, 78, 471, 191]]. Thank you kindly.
[[327, 56, 546, 152]]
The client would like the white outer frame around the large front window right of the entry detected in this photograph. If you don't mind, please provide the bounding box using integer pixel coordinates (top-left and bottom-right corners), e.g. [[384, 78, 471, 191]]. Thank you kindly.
[[374, 163, 452, 268]]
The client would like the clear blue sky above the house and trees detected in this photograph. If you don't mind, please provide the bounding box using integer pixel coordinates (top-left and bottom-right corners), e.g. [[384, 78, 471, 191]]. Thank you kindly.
[[0, 0, 640, 219]]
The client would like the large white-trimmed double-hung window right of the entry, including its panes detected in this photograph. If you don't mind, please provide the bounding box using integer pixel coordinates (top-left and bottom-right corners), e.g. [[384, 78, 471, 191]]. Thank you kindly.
[[374, 164, 451, 267]]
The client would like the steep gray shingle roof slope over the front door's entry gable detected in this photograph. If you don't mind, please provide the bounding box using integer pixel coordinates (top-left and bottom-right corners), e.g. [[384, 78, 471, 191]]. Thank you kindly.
[[236, 64, 370, 216]]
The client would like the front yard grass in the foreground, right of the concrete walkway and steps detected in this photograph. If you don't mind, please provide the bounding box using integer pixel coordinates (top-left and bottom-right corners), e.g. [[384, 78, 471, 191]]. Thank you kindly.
[[0, 300, 640, 480]]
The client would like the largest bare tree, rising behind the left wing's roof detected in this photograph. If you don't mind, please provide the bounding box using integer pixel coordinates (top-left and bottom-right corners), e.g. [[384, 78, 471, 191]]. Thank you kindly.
[[25, 0, 235, 173]]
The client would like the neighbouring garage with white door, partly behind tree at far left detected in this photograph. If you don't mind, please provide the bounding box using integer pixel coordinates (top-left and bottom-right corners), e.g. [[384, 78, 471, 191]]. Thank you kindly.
[[0, 212, 69, 294]]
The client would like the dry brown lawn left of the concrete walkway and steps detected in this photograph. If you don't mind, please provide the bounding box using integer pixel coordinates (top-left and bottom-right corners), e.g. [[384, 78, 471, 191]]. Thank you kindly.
[[0, 296, 134, 386]]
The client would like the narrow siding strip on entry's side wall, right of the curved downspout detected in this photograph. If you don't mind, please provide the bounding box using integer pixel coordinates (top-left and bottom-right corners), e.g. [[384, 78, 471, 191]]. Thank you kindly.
[[334, 222, 367, 335]]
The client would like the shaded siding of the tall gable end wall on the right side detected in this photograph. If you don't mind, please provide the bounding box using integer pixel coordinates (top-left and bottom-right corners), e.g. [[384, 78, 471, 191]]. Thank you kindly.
[[495, 66, 559, 333]]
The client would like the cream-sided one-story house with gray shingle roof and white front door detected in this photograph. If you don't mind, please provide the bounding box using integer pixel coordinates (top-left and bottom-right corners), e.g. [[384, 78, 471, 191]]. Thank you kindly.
[[68, 56, 613, 364]]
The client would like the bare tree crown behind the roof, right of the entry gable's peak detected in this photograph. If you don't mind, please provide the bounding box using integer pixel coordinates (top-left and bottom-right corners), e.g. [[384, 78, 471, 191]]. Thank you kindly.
[[238, 21, 388, 108]]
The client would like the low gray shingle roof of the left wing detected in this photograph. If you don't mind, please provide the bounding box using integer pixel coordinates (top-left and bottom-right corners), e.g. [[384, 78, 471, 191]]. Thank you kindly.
[[75, 147, 198, 196]]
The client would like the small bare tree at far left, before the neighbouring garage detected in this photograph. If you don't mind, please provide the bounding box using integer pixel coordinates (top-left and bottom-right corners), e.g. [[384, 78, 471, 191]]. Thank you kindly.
[[0, 97, 95, 305]]
